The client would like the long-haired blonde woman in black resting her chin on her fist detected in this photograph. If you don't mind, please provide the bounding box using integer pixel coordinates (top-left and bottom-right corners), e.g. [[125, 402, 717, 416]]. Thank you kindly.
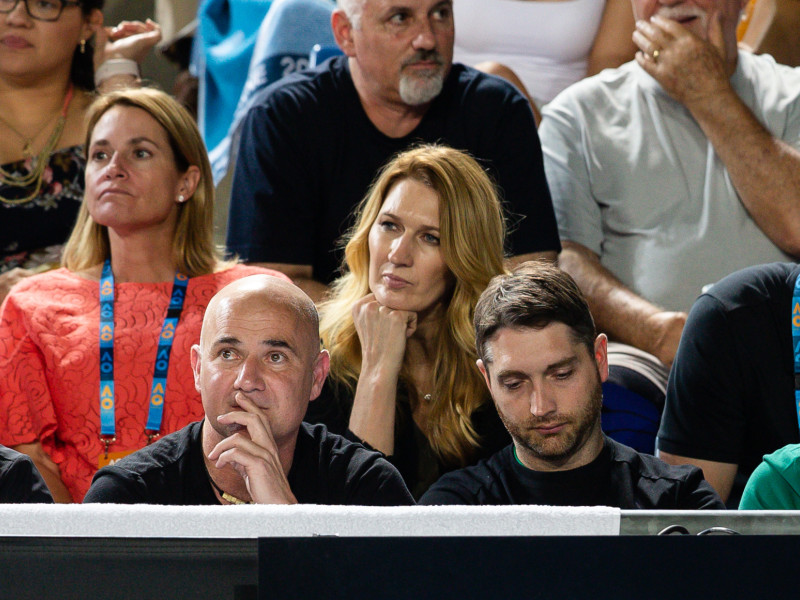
[[307, 146, 509, 497]]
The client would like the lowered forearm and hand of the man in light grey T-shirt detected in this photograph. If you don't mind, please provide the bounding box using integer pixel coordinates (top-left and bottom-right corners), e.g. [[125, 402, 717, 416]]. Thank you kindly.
[[558, 240, 686, 365]]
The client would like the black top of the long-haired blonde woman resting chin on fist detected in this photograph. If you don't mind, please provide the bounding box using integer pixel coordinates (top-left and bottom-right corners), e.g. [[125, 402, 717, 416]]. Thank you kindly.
[[305, 377, 511, 498]]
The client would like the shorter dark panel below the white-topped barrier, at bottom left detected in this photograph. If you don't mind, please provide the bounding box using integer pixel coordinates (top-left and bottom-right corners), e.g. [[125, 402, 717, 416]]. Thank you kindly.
[[0, 538, 257, 600]]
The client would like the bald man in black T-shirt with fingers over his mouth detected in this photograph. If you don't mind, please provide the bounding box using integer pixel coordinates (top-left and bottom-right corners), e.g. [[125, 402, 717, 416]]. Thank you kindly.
[[84, 275, 414, 505]]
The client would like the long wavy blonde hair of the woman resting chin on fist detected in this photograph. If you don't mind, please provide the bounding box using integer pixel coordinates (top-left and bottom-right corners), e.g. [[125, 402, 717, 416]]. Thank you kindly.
[[320, 145, 505, 465]]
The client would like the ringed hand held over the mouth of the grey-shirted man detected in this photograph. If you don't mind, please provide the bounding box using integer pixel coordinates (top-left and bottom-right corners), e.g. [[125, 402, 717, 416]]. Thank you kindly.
[[633, 13, 735, 110]]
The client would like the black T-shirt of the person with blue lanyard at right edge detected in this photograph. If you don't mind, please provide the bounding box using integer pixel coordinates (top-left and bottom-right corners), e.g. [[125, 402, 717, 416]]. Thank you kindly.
[[658, 263, 800, 476]]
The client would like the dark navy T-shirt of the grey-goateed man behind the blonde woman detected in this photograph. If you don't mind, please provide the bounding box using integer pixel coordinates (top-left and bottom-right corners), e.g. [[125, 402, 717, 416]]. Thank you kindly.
[[227, 57, 560, 283]]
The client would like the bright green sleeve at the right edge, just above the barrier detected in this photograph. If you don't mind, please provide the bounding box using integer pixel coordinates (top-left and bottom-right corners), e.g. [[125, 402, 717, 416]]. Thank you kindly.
[[739, 444, 800, 510]]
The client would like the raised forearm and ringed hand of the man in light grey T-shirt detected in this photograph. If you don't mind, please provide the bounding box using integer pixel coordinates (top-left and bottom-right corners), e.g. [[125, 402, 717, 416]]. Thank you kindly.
[[634, 14, 800, 256]]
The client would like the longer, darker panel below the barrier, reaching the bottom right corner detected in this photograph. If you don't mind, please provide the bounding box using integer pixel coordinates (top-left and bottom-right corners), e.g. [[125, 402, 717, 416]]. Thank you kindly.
[[258, 536, 800, 600]]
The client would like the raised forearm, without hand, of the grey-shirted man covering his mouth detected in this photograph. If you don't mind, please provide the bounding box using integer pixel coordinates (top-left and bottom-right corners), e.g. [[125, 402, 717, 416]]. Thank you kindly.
[[687, 89, 800, 256]]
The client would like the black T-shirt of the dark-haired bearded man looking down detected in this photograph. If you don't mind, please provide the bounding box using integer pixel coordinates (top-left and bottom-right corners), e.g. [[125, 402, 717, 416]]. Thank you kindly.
[[419, 436, 725, 510]]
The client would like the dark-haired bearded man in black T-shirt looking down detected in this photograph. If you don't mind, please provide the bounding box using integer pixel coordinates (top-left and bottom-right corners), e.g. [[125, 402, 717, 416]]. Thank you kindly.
[[420, 263, 725, 510]]
